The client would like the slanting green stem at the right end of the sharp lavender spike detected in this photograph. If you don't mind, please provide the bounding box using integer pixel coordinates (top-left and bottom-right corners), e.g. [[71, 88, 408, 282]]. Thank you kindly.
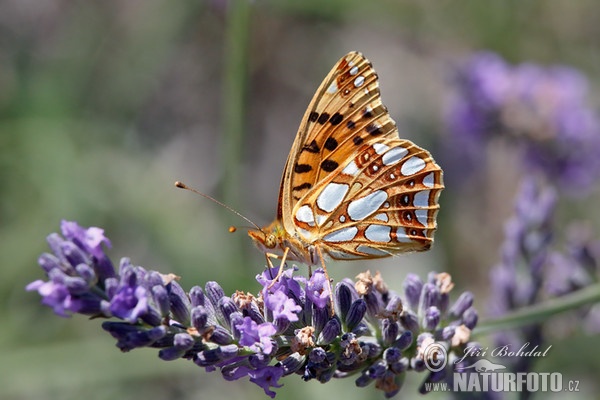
[[473, 283, 600, 335]]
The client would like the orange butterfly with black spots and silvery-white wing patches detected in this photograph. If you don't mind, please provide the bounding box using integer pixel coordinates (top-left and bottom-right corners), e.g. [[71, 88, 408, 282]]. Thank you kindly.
[[248, 52, 444, 267]]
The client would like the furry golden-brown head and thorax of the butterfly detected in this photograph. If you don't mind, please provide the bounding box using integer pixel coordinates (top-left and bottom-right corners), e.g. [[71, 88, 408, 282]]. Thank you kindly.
[[248, 219, 318, 265]]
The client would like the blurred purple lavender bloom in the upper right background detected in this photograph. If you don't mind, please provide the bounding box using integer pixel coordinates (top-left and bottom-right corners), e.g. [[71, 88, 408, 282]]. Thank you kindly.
[[446, 52, 600, 193]]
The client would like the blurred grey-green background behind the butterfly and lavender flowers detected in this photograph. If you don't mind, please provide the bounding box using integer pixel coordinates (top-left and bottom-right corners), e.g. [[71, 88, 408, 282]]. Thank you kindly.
[[0, 0, 600, 400]]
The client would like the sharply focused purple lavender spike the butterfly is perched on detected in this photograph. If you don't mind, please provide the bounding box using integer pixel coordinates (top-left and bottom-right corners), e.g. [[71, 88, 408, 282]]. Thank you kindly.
[[27, 222, 477, 397]]
